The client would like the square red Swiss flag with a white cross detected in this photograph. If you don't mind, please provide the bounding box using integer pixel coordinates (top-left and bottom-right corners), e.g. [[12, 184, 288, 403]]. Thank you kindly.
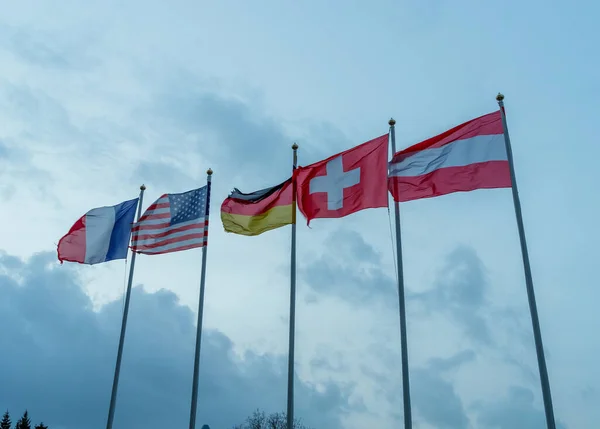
[[294, 134, 388, 223]]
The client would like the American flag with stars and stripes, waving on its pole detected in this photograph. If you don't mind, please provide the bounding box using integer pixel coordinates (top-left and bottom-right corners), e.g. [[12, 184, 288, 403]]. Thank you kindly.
[[131, 185, 210, 255]]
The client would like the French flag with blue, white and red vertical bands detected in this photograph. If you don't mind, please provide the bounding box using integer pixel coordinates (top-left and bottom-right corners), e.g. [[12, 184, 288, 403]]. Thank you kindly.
[[57, 198, 139, 265]]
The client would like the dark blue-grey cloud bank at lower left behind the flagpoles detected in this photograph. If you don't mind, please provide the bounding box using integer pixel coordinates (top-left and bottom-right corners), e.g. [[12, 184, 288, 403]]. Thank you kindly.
[[0, 253, 350, 429]]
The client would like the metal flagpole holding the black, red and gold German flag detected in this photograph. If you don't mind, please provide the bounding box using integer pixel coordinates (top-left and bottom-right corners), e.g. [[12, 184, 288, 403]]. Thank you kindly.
[[287, 143, 298, 429]]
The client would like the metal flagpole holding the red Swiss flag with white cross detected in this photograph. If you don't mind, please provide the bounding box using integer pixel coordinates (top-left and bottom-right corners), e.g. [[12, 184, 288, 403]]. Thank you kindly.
[[388, 118, 412, 429]]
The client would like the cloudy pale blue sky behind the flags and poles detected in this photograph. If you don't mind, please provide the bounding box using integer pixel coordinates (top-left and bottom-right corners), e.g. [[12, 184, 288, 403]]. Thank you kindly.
[[0, 0, 600, 429]]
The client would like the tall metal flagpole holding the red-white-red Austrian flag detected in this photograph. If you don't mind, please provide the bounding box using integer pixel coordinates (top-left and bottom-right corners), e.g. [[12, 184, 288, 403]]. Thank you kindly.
[[496, 93, 556, 429]]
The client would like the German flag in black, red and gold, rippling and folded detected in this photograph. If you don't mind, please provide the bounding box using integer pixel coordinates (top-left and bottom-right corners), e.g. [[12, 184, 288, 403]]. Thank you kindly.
[[221, 178, 294, 235]]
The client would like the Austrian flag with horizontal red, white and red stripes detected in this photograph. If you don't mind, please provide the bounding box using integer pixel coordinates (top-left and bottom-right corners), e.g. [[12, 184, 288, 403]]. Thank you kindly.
[[388, 111, 511, 202]]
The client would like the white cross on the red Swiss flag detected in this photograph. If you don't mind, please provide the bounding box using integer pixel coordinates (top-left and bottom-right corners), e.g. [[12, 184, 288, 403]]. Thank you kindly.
[[309, 156, 360, 210]]
